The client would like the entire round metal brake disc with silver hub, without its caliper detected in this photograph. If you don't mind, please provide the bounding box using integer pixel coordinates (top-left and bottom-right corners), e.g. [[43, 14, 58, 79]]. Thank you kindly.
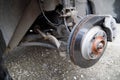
[[67, 16, 107, 68]]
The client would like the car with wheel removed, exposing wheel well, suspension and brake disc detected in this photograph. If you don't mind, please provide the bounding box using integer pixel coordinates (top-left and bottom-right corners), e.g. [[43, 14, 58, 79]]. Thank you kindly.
[[0, 0, 120, 80]]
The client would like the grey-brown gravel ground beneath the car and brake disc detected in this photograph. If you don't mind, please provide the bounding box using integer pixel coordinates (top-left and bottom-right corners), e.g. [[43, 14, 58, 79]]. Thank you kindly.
[[6, 24, 120, 80]]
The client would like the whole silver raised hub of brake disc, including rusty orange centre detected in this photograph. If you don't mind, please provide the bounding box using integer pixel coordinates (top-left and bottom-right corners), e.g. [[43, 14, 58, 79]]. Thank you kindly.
[[81, 26, 107, 60]]
